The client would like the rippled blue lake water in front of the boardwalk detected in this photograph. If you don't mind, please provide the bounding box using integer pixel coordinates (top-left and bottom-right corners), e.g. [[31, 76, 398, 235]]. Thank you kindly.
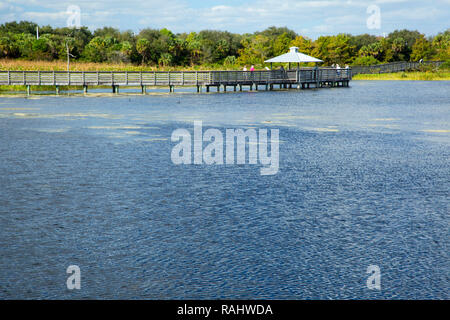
[[0, 81, 450, 299]]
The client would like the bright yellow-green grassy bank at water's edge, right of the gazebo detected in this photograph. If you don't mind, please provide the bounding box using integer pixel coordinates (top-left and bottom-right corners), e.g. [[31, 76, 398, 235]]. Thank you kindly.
[[353, 70, 450, 80]]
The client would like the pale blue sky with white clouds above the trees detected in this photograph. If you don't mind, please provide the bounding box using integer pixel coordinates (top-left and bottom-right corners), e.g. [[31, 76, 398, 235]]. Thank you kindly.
[[0, 0, 450, 38]]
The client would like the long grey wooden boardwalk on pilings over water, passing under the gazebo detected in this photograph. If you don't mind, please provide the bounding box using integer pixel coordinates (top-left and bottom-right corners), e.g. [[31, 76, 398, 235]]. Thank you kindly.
[[0, 68, 352, 94]]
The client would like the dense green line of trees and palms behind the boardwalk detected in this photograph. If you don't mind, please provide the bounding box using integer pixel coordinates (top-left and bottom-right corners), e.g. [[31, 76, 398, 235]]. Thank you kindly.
[[0, 21, 450, 67]]
